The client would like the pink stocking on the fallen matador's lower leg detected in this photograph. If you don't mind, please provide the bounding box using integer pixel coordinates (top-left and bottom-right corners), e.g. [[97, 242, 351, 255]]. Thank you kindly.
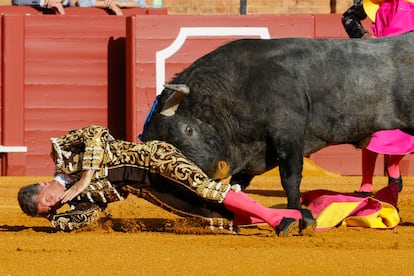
[[224, 190, 302, 228]]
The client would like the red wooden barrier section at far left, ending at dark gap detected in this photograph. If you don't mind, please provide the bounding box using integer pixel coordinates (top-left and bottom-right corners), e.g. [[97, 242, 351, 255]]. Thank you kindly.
[[0, 7, 166, 175]]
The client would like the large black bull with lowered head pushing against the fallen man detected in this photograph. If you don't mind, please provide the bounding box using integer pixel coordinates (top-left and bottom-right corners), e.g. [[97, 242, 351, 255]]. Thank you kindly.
[[142, 33, 414, 208]]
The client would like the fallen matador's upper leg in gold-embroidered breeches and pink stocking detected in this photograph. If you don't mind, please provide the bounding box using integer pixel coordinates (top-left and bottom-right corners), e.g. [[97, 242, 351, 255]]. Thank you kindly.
[[143, 141, 315, 236]]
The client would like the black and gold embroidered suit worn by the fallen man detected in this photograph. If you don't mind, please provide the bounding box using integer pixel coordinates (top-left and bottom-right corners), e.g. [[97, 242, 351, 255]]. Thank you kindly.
[[51, 125, 239, 231]]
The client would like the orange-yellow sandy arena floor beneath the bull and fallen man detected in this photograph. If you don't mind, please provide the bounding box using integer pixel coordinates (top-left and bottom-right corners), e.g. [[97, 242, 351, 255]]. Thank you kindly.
[[0, 162, 414, 275]]
